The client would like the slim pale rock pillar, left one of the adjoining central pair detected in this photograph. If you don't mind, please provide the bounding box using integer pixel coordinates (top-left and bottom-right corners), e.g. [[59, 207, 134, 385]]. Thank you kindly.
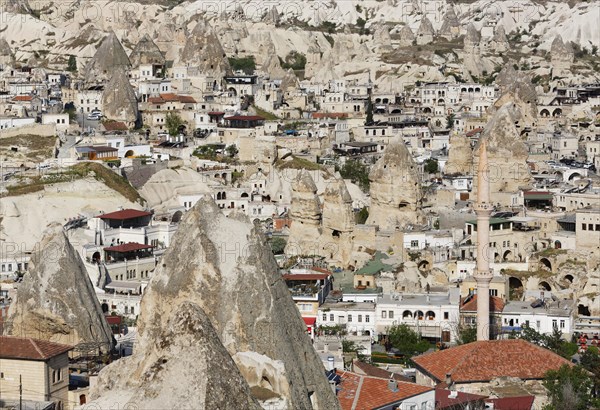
[[286, 170, 321, 255]]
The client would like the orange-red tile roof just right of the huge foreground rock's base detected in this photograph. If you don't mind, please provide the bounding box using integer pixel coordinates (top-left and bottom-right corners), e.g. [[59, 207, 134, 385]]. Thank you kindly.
[[337, 371, 433, 410]]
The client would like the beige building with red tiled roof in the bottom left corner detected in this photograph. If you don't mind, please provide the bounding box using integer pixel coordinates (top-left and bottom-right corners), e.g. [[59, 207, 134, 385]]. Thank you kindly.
[[0, 336, 73, 410]]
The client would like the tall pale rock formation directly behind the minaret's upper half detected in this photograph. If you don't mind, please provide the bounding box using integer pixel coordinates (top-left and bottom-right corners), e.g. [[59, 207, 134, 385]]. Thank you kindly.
[[473, 103, 531, 206]]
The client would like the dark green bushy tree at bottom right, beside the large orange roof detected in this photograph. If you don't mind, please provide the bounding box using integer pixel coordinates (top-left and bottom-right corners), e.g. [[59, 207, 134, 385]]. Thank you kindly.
[[543, 364, 599, 410]]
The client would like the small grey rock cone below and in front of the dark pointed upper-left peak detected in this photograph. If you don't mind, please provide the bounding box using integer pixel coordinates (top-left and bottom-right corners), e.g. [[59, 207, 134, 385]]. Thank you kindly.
[[102, 68, 139, 127]]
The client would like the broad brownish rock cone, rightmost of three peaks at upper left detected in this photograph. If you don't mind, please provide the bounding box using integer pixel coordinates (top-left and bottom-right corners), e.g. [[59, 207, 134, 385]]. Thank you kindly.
[[180, 19, 231, 77]]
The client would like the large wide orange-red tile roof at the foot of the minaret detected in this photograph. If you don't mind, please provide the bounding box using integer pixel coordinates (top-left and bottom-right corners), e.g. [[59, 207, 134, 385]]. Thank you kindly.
[[413, 339, 572, 383]]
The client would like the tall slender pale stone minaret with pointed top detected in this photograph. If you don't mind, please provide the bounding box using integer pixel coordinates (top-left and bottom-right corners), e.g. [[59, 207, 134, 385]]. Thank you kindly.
[[475, 140, 493, 340]]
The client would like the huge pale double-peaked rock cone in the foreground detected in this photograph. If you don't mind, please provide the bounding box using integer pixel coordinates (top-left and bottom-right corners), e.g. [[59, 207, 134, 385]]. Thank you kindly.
[[91, 197, 339, 409]]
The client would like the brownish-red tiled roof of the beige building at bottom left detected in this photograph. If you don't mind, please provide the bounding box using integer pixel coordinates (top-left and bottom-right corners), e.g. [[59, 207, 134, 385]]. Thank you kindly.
[[0, 336, 73, 361]]
